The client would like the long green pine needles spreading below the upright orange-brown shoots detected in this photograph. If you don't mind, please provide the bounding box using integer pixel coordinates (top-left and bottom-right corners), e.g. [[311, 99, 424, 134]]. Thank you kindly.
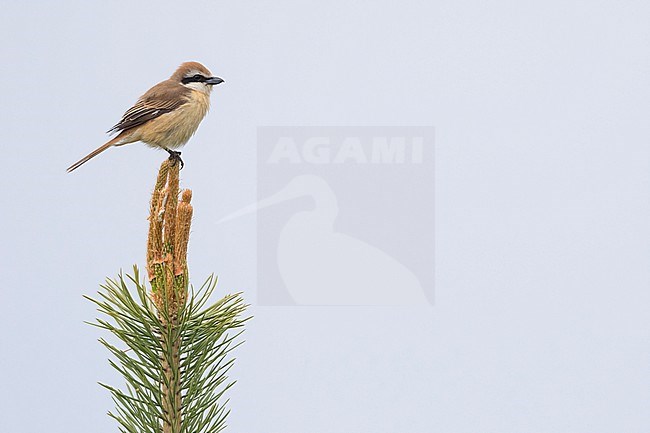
[[85, 267, 249, 433]]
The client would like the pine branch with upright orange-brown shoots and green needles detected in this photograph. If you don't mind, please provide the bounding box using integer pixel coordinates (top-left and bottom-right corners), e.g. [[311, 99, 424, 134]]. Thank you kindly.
[[87, 161, 248, 433]]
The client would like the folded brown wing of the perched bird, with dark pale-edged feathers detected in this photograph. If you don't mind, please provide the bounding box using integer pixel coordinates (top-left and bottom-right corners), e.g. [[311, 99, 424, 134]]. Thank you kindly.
[[108, 81, 188, 134]]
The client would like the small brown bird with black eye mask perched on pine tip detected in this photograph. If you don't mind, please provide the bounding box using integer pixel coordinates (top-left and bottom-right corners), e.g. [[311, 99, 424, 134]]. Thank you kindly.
[[68, 62, 223, 173]]
